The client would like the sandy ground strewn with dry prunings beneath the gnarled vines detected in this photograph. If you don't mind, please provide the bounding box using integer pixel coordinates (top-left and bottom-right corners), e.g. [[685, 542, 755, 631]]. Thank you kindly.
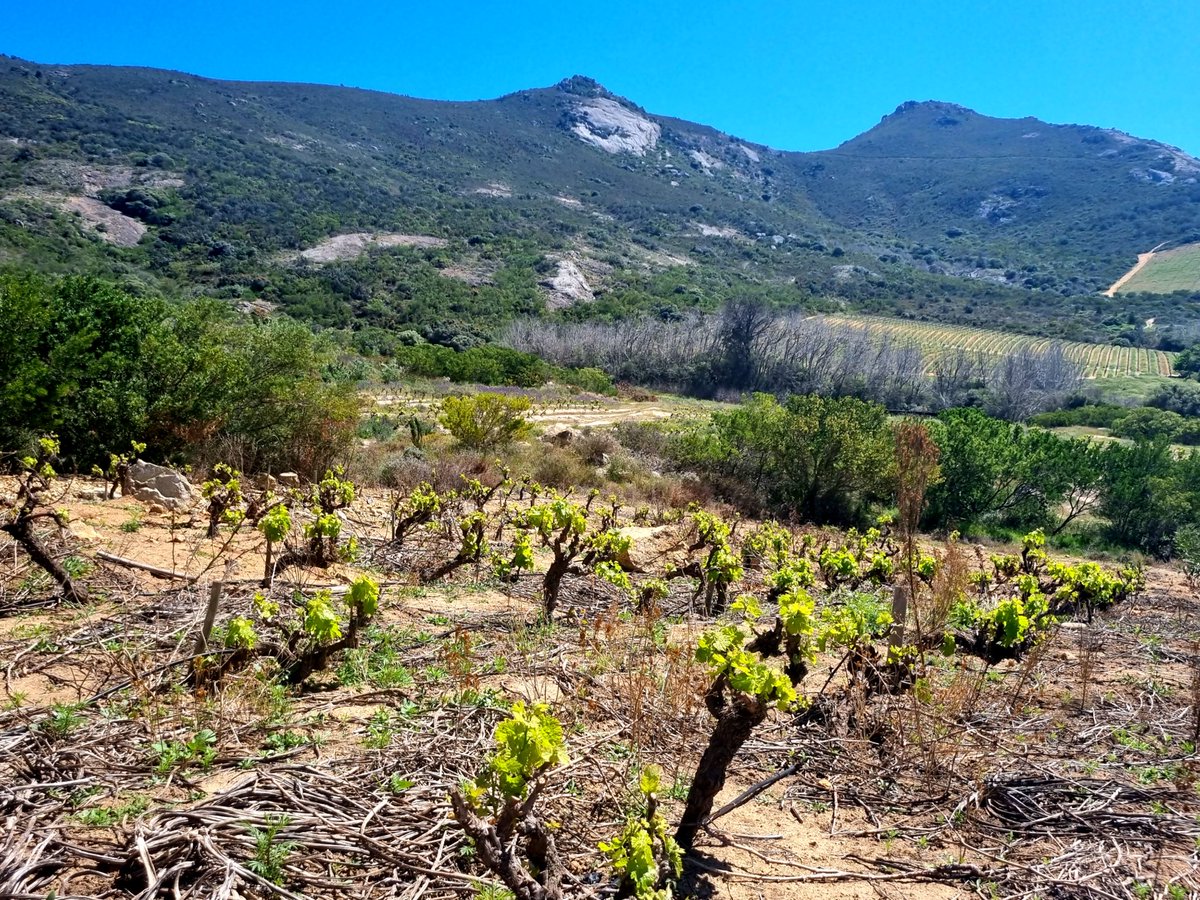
[[0, 475, 1200, 900]]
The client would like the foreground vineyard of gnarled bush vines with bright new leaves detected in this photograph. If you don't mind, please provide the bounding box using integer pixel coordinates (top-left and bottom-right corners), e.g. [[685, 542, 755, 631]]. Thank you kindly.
[[0, 434, 1200, 900]]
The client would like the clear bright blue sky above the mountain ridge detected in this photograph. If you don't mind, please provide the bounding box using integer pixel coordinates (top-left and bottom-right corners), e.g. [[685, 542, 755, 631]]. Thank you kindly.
[[9, 0, 1200, 155]]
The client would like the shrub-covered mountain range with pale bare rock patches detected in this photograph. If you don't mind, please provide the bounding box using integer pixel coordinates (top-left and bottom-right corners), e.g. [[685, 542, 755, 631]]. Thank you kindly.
[[0, 56, 1200, 341]]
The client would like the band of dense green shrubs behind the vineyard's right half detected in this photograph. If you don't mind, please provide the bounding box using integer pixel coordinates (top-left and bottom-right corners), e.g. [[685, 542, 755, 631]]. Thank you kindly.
[[620, 394, 1200, 556]]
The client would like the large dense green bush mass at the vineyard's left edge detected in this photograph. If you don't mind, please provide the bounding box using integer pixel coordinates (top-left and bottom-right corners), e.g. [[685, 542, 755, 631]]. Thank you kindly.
[[0, 275, 359, 475]]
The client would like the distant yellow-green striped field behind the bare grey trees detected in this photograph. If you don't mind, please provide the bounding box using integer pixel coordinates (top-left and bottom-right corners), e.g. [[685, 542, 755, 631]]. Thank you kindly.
[[824, 314, 1171, 378]]
